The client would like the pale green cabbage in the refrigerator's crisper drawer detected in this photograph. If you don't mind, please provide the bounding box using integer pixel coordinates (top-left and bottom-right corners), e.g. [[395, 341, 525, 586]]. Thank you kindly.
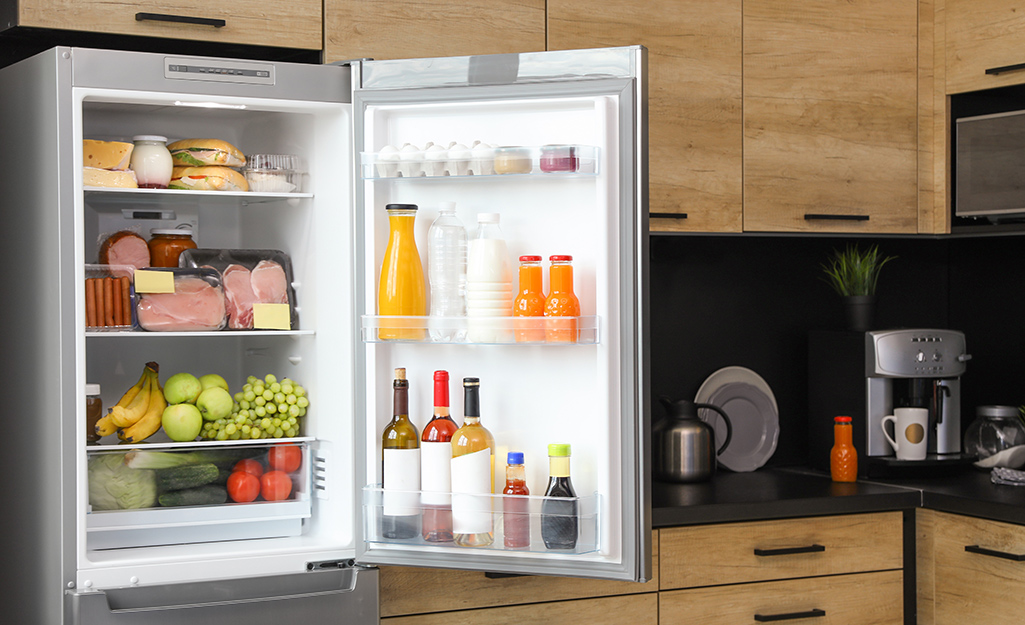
[[89, 454, 157, 510]]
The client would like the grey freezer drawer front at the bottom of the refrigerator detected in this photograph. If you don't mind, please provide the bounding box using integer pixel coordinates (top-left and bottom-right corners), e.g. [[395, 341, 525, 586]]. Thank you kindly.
[[65, 568, 377, 625]]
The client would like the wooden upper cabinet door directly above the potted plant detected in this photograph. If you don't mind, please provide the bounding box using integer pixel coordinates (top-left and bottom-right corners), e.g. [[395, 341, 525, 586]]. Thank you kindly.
[[743, 0, 918, 234]]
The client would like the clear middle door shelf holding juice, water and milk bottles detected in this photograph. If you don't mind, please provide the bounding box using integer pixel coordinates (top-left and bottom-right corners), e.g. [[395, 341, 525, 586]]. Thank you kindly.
[[362, 315, 600, 345]]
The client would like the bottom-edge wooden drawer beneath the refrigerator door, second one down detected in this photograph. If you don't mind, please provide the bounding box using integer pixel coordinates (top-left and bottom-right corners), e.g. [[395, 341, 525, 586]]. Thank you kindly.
[[381, 582, 658, 625]]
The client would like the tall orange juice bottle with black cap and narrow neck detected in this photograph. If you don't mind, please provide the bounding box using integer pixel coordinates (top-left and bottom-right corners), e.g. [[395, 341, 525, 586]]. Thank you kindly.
[[377, 204, 427, 340]]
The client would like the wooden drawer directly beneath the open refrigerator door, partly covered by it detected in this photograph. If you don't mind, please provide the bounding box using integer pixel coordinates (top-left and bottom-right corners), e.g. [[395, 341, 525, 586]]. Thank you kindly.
[[379, 530, 659, 622]]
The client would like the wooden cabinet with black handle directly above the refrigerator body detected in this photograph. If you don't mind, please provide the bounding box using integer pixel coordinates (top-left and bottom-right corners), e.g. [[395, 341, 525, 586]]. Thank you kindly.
[[0, 0, 323, 49]]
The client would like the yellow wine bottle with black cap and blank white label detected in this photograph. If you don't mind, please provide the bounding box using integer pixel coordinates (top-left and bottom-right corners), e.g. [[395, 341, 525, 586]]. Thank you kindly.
[[452, 378, 495, 547]]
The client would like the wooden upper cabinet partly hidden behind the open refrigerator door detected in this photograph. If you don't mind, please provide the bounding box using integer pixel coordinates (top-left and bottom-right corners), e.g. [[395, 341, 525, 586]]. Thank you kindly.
[[548, 0, 743, 233]]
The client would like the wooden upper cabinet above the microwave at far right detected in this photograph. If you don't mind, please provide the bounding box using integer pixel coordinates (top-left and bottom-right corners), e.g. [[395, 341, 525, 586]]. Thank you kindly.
[[937, 0, 1025, 93]]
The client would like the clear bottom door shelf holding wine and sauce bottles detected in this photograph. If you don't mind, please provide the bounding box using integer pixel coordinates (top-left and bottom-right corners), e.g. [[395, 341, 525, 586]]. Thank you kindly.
[[363, 484, 601, 555]]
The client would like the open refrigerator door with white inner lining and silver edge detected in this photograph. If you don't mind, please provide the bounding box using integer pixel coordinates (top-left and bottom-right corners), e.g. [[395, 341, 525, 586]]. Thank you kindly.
[[353, 46, 651, 581]]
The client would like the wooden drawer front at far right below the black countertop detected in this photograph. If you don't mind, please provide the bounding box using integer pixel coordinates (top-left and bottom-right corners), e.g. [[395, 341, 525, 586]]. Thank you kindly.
[[932, 512, 1025, 625]]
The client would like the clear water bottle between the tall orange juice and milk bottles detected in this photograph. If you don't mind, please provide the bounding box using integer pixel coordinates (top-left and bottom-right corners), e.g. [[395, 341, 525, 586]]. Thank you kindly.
[[427, 202, 466, 342]]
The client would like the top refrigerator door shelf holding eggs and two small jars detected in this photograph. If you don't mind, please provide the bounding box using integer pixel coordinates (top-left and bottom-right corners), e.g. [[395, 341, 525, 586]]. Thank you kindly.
[[360, 142, 599, 180]]
